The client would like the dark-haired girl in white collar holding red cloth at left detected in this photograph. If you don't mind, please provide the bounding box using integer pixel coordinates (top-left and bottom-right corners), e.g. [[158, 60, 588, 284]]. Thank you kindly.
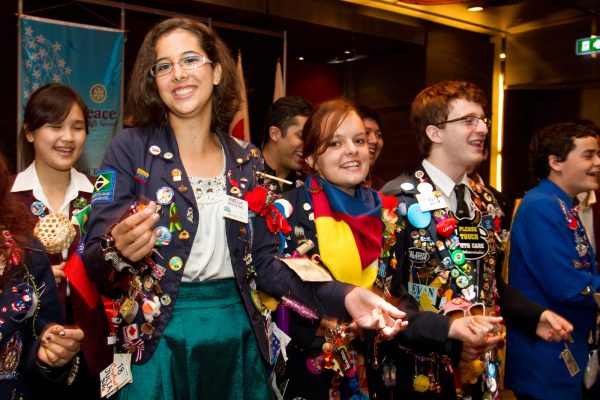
[[11, 83, 112, 399]]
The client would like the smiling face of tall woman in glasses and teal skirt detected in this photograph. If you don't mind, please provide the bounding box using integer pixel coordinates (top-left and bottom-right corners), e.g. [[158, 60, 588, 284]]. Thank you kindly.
[[155, 29, 221, 120]]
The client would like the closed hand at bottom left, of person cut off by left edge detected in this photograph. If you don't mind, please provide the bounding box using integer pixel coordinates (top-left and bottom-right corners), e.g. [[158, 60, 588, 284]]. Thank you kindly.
[[37, 324, 85, 367]]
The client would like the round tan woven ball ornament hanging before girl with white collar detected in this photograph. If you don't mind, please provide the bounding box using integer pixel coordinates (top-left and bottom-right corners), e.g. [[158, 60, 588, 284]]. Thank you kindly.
[[33, 213, 76, 254]]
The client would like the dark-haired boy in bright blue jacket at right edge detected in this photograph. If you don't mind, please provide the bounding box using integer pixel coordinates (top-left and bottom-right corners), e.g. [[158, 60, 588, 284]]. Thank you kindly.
[[506, 123, 600, 400]]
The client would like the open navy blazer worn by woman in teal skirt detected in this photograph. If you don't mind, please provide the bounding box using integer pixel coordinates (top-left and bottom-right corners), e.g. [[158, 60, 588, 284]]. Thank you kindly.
[[84, 126, 351, 364]]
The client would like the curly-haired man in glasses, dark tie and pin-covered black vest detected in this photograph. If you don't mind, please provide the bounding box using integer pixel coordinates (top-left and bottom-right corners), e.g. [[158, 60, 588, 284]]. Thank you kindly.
[[378, 81, 572, 399]]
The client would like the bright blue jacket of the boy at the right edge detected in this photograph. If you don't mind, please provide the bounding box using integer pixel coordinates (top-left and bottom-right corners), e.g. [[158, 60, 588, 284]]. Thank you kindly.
[[506, 179, 600, 399]]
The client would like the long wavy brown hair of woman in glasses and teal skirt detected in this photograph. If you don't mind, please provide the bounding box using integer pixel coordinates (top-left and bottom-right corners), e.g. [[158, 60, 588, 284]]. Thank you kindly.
[[125, 18, 240, 132]]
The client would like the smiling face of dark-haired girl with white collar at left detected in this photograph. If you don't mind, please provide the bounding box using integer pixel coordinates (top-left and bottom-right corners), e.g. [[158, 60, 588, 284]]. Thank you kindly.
[[25, 103, 86, 171]]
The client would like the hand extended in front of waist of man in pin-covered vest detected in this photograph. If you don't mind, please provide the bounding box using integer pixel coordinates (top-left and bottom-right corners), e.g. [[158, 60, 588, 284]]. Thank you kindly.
[[448, 315, 504, 361]]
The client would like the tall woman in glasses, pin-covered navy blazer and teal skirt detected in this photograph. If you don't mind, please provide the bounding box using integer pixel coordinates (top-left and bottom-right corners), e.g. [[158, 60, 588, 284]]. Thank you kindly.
[[85, 18, 403, 400]]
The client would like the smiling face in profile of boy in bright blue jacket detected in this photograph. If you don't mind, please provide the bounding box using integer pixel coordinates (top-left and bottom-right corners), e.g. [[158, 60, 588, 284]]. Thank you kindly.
[[548, 136, 600, 198]]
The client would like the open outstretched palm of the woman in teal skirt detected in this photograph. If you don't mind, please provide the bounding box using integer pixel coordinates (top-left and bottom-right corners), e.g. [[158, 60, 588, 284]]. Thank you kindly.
[[344, 287, 408, 337]]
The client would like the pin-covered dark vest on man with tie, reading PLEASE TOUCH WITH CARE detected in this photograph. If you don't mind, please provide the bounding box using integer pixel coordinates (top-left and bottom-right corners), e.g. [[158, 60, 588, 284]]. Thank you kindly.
[[390, 170, 503, 399]]
